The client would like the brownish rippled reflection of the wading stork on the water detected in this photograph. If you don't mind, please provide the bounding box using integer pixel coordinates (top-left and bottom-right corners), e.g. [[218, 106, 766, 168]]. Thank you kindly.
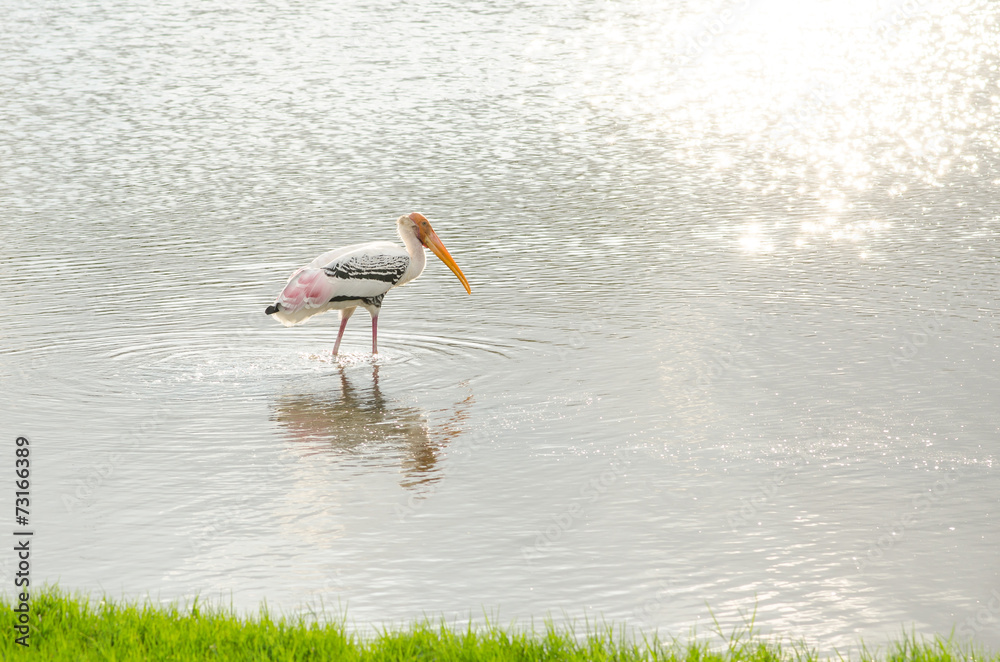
[[272, 365, 473, 489]]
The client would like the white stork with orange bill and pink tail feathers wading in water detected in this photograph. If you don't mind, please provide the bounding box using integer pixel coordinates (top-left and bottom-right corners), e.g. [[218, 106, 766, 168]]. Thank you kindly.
[[264, 212, 472, 356]]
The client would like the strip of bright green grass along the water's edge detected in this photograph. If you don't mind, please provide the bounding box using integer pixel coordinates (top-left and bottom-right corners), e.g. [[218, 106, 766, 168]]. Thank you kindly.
[[0, 588, 1000, 662]]
